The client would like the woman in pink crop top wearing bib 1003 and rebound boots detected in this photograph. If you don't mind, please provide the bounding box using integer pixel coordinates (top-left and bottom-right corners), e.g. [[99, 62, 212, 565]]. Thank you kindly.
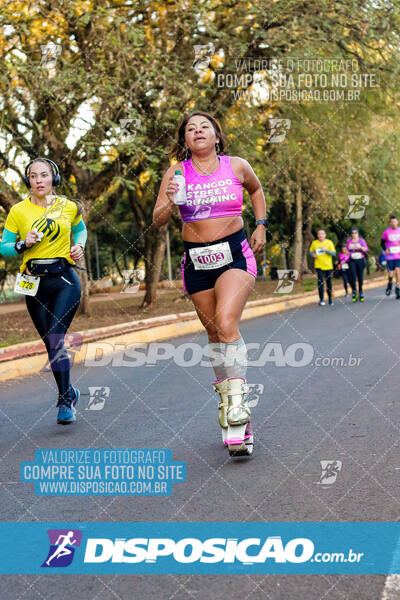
[[153, 111, 266, 456]]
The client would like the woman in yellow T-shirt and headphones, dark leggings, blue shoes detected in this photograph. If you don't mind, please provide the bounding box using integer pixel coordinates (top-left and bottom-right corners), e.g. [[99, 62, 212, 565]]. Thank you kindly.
[[0, 158, 87, 425]]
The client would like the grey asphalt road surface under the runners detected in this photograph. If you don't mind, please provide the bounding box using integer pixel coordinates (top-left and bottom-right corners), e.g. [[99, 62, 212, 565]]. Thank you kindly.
[[0, 288, 400, 600]]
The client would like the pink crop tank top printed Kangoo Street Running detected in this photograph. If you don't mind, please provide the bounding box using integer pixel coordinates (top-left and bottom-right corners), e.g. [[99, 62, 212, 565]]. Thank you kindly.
[[179, 154, 243, 223]]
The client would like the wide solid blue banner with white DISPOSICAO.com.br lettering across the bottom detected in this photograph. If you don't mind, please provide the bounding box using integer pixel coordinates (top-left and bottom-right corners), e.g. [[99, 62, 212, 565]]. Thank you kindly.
[[0, 522, 400, 575]]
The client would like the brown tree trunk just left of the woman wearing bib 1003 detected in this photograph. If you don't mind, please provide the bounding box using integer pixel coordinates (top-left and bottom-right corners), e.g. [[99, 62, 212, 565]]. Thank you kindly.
[[142, 225, 167, 308]]
